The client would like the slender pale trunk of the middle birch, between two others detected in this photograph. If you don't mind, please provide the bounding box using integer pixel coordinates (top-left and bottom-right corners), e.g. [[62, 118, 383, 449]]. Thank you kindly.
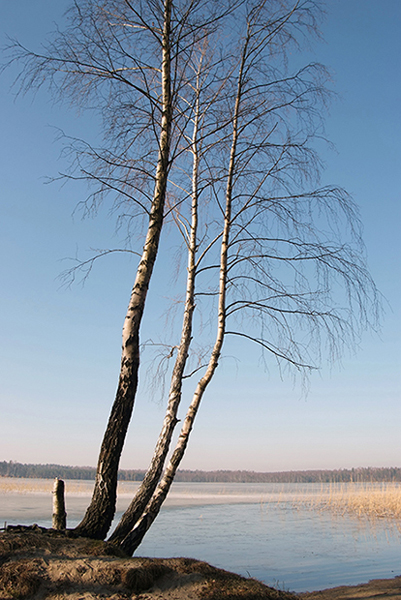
[[109, 82, 199, 544]]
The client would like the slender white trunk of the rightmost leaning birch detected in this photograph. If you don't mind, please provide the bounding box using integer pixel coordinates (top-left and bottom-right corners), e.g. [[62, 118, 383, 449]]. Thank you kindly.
[[120, 44, 248, 555]]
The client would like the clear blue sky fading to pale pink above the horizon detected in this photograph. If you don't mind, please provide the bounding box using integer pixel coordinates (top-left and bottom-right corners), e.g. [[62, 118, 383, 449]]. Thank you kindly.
[[0, 0, 401, 471]]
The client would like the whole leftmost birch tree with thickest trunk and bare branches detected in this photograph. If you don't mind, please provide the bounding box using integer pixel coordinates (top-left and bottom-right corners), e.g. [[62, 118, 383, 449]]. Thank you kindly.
[[9, 0, 234, 539]]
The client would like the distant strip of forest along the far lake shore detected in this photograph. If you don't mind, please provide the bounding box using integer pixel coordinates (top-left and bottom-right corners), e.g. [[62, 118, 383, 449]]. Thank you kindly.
[[0, 461, 401, 483]]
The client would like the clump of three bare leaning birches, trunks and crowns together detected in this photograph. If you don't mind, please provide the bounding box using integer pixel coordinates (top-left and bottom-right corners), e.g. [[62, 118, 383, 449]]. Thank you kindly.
[[2, 0, 380, 553]]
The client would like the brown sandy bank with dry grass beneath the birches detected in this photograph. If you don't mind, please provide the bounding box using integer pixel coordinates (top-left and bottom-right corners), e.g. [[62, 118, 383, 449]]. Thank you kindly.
[[0, 528, 401, 600]]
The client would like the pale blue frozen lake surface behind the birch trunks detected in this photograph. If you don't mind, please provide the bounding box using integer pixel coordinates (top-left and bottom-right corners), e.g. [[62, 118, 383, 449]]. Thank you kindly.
[[0, 478, 401, 592]]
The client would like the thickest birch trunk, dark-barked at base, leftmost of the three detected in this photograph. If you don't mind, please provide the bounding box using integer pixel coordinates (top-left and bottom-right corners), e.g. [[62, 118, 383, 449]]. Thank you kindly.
[[76, 0, 172, 539]]
